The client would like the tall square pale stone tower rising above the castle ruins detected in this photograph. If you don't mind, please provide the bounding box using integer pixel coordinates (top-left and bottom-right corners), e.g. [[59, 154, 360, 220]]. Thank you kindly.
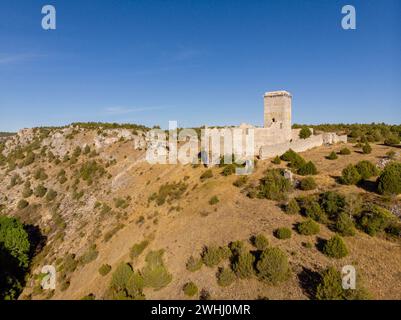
[[264, 91, 292, 141]]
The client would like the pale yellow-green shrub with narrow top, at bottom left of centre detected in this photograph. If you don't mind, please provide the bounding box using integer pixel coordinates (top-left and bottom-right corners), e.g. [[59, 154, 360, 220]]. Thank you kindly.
[[141, 250, 173, 290]]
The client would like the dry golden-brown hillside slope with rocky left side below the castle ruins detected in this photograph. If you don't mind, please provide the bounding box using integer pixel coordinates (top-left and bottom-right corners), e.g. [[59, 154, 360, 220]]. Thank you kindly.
[[0, 127, 401, 299]]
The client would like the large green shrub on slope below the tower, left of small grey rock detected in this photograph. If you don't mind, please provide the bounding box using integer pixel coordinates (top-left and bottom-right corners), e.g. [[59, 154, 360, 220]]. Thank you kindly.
[[259, 169, 292, 200]]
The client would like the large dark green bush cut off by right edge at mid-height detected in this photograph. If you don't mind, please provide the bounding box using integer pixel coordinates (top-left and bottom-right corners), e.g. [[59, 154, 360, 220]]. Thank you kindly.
[[377, 162, 401, 195]]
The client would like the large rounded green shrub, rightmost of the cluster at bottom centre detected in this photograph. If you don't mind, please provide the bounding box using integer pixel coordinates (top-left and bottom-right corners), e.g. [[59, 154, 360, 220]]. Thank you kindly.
[[256, 248, 291, 284]]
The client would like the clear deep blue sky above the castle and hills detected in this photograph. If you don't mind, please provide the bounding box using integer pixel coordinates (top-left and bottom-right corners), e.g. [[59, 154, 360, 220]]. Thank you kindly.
[[0, 0, 401, 131]]
